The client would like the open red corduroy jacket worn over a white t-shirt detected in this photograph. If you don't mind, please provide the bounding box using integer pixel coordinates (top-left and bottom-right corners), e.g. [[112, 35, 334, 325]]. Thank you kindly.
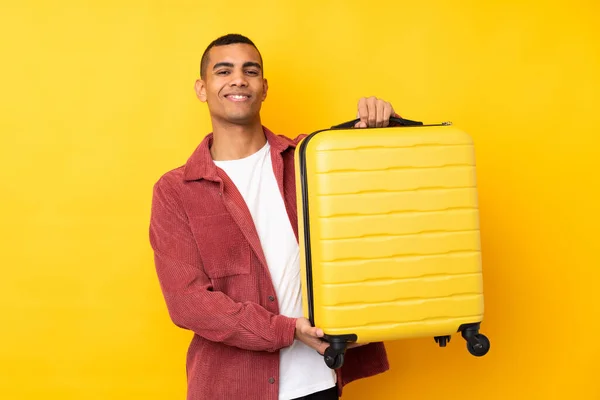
[[150, 128, 389, 400]]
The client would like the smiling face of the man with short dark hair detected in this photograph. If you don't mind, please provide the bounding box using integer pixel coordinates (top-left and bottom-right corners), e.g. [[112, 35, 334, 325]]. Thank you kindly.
[[195, 43, 268, 125]]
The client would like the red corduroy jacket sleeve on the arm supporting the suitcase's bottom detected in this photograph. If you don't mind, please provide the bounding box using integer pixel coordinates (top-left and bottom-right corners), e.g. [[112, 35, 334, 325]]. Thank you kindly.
[[150, 177, 296, 352]]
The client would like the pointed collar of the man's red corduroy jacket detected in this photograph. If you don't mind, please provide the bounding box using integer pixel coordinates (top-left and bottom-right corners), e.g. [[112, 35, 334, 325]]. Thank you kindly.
[[183, 126, 296, 181]]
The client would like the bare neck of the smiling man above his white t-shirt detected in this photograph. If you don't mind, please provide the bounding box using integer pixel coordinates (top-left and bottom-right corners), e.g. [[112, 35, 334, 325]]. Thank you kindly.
[[210, 121, 267, 161]]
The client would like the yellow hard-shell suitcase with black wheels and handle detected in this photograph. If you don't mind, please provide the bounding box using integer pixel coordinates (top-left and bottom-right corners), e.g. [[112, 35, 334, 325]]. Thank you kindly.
[[295, 117, 490, 369]]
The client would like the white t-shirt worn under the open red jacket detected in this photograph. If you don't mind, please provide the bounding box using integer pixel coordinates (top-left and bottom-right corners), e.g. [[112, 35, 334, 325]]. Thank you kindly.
[[215, 142, 336, 400]]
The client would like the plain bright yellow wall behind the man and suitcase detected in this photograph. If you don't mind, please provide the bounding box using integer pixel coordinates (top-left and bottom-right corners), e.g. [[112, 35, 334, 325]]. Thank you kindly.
[[0, 0, 600, 400]]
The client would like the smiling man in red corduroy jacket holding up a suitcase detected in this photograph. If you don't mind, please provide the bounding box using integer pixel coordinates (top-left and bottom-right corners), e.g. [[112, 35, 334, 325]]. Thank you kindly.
[[150, 34, 395, 400]]
